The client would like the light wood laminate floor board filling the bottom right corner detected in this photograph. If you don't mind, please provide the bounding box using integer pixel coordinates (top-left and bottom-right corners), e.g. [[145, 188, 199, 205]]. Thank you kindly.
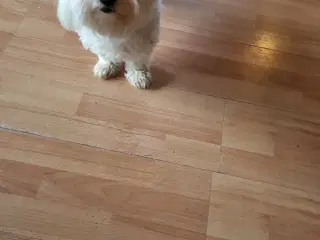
[[207, 173, 320, 240]]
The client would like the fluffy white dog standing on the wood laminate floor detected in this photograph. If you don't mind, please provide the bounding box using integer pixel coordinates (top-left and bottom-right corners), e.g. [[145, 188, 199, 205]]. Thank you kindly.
[[58, 0, 161, 89]]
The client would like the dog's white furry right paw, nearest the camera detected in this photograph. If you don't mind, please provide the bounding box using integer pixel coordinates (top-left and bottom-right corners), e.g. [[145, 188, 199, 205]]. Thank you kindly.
[[126, 69, 152, 89]]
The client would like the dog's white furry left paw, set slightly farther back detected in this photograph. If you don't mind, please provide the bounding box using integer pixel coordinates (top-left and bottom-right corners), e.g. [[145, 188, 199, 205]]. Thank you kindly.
[[93, 61, 121, 79]]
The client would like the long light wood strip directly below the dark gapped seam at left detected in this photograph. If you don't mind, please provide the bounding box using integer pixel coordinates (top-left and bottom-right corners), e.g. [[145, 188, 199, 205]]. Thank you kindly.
[[0, 130, 211, 200]]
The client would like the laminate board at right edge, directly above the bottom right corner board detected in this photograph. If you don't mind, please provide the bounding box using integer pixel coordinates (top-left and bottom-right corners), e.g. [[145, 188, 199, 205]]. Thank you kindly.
[[219, 102, 320, 193]]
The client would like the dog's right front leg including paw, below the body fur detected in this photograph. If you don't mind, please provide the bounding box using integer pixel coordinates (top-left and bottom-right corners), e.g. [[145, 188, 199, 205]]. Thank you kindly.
[[126, 61, 152, 89]]
